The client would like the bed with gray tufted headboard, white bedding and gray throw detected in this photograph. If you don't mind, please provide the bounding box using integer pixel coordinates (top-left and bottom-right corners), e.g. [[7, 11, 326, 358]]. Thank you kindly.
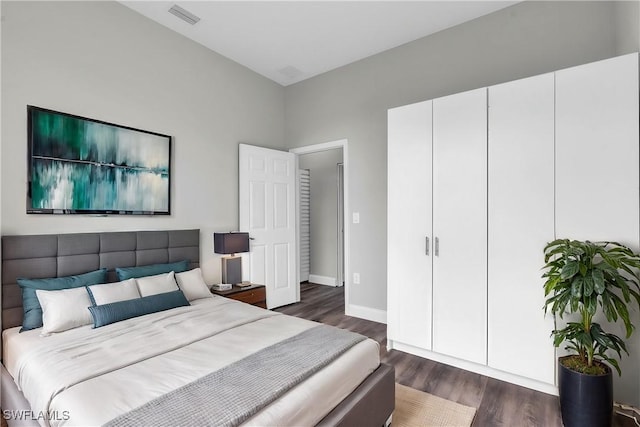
[[1, 230, 394, 426]]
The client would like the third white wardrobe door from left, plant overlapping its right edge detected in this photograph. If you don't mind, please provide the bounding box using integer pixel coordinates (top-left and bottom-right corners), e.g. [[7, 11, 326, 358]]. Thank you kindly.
[[488, 73, 555, 384]]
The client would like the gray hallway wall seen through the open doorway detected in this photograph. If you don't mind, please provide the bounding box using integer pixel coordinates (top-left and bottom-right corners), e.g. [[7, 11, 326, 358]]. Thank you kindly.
[[299, 149, 342, 281]]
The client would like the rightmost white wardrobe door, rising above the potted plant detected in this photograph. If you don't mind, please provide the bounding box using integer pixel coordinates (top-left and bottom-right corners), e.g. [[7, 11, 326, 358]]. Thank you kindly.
[[556, 54, 639, 249]]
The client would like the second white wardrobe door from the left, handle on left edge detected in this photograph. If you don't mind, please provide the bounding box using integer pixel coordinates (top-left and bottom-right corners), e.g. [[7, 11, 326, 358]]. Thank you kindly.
[[433, 88, 487, 364]]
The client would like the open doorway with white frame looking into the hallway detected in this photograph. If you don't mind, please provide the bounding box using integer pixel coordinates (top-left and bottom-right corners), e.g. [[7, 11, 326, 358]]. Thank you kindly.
[[289, 140, 349, 309]]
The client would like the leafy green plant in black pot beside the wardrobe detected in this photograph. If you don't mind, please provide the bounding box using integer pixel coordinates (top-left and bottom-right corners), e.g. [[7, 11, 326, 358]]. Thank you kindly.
[[542, 239, 640, 427]]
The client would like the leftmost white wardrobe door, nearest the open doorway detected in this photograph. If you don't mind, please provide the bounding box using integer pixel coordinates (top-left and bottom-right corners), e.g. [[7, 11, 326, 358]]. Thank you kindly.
[[387, 101, 432, 349]]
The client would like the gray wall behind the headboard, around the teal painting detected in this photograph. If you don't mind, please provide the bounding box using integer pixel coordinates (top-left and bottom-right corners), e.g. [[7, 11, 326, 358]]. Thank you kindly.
[[0, 1, 284, 283]]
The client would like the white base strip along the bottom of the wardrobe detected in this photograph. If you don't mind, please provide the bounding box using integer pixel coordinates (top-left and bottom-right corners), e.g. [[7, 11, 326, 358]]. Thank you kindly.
[[387, 339, 558, 396]]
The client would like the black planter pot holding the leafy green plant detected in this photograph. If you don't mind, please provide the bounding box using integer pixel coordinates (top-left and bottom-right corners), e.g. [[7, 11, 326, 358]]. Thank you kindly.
[[558, 357, 613, 427]]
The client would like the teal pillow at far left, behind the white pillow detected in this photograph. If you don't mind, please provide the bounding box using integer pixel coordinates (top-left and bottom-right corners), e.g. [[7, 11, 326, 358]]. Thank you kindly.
[[17, 268, 107, 332]]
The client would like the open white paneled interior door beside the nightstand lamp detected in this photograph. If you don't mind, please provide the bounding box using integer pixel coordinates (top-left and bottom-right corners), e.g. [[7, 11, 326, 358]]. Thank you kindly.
[[239, 144, 299, 308]]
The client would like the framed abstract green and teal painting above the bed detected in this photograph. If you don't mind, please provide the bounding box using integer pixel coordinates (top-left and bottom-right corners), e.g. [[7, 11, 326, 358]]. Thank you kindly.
[[29, 107, 171, 214]]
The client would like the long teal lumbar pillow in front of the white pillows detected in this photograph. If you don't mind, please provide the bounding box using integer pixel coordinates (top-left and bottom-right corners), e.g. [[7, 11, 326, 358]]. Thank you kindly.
[[89, 291, 191, 328]]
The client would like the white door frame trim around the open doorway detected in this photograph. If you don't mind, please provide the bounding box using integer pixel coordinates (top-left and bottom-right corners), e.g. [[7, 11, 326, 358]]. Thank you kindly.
[[289, 139, 351, 313]]
